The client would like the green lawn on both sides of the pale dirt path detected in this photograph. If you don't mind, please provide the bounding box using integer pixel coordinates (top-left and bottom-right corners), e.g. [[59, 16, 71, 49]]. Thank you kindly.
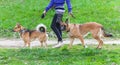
[[0, 0, 120, 65]]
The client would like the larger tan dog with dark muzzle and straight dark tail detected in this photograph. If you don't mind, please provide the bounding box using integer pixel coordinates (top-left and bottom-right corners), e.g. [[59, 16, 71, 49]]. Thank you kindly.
[[61, 19, 112, 48]]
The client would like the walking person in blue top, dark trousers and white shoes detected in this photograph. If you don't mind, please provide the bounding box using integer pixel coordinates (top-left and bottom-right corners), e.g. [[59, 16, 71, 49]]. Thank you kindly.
[[41, 0, 72, 48]]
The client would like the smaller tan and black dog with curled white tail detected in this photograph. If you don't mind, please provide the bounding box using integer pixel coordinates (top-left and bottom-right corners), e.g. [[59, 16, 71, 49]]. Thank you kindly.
[[13, 24, 47, 47]]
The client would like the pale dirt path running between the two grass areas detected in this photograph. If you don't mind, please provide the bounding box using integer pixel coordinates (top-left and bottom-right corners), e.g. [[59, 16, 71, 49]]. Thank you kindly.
[[0, 39, 120, 48]]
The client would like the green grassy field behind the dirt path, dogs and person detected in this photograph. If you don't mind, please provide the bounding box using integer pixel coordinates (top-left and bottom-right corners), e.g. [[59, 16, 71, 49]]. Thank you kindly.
[[0, 0, 120, 37]]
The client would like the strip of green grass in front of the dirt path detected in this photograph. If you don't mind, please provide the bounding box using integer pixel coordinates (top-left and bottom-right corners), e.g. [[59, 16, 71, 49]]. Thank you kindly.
[[0, 45, 120, 65]]
